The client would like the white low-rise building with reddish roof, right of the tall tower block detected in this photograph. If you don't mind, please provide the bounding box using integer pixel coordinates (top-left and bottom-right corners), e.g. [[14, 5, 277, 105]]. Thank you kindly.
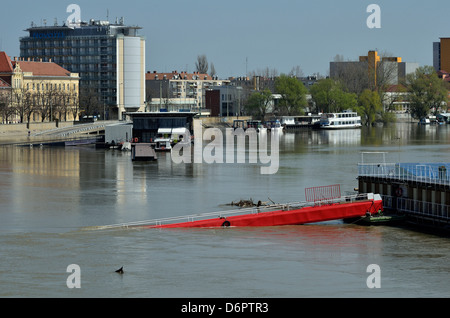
[[145, 71, 230, 112]]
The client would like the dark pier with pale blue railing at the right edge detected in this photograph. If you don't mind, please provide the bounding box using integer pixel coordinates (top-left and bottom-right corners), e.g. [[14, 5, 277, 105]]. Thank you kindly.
[[358, 153, 450, 230]]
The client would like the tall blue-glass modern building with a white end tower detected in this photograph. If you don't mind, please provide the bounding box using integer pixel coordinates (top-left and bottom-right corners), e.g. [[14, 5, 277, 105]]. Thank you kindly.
[[20, 18, 145, 119]]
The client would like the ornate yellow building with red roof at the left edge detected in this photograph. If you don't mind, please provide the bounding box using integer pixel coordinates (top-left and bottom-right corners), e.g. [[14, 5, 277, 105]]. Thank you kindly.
[[0, 52, 80, 123]]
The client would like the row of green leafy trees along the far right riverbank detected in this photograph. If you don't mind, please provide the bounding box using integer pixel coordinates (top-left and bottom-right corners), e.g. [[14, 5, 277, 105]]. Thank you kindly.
[[245, 64, 450, 126]]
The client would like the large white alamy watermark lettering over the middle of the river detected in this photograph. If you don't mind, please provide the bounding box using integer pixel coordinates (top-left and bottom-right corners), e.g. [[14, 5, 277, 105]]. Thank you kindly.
[[171, 120, 280, 174]]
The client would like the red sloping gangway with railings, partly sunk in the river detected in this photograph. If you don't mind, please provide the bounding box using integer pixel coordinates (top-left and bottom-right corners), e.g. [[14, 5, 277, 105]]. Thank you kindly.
[[92, 185, 383, 229]]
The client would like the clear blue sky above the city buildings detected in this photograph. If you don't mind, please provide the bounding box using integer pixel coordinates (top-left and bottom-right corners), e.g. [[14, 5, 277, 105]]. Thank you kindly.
[[0, 0, 450, 79]]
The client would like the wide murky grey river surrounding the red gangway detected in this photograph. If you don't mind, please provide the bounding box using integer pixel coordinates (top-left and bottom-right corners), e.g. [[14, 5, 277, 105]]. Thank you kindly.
[[0, 123, 450, 298]]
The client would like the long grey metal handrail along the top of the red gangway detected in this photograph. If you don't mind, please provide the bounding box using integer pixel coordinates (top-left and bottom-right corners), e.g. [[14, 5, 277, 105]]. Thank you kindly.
[[84, 193, 373, 230]]
